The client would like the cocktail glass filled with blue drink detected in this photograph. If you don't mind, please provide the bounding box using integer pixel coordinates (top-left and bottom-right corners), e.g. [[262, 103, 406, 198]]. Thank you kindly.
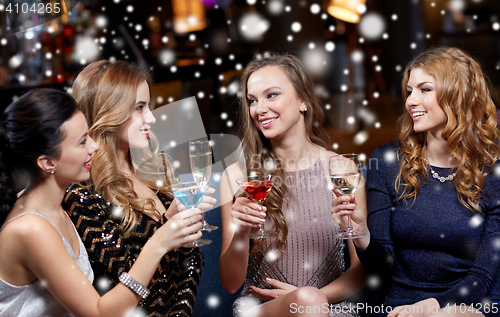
[[172, 182, 212, 248]]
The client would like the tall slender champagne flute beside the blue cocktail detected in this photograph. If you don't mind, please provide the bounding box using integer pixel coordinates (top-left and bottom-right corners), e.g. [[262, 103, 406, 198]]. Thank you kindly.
[[189, 141, 217, 231]]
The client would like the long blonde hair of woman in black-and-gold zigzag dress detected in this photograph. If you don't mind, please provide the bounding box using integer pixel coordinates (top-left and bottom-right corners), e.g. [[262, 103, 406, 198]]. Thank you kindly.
[[72, 60, 173, 233]]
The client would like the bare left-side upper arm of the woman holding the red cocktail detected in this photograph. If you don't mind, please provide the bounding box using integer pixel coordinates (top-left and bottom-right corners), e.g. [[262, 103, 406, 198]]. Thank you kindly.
[[220, 164, 244, 256]]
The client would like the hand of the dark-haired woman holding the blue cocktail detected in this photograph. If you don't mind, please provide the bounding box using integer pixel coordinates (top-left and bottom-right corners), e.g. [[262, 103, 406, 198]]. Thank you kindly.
[[150, 208, 202, 253]]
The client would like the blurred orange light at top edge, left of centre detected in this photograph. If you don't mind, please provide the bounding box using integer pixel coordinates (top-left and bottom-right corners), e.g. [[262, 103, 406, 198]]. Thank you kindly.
[[172, 0, 207, 33]]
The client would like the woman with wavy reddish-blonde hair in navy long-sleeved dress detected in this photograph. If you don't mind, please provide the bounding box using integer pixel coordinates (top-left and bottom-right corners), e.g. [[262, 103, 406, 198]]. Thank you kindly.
[[332, 47, 500, 317]]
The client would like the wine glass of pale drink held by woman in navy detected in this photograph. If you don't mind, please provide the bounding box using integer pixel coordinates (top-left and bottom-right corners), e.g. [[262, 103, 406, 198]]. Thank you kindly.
[[329, 154, 366, 239]]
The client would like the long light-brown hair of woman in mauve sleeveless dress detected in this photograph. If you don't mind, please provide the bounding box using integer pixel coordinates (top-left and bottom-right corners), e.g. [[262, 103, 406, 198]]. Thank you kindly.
[[240, 53, 332, 254]]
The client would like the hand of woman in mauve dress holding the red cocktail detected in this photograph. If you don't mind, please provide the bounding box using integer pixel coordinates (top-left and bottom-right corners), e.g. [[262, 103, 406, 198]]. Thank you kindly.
[[231, 197, 267, 235]]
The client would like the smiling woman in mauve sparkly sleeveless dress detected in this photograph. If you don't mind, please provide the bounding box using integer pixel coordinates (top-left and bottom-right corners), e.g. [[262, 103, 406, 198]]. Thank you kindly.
[[219, 54, 365, 316]]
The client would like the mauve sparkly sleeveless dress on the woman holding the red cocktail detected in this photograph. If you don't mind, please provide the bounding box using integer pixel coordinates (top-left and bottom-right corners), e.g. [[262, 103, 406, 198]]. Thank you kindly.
[[233, 159, 355, 317]]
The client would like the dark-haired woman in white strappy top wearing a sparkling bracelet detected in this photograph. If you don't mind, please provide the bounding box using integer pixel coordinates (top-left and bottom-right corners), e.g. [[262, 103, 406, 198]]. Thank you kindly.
[[0, 89, 201, 317]]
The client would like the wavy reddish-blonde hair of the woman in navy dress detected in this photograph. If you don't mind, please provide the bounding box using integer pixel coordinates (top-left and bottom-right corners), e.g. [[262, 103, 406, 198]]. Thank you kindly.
[[395, 47, 499, 212]]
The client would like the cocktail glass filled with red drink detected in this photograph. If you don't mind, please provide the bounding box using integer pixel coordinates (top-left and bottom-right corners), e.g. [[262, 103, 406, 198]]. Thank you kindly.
[[236, 174, 276, 239]]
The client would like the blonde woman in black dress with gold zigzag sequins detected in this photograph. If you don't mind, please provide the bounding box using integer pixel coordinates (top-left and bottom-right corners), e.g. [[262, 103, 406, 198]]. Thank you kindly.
[[63, 60, 215, 316]]
